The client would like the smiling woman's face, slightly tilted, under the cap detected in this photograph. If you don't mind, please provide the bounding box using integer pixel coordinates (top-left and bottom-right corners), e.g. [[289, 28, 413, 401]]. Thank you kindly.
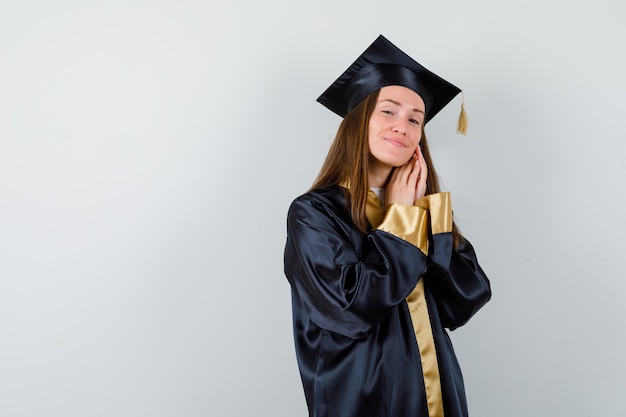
[[368, 85, 425, 169]]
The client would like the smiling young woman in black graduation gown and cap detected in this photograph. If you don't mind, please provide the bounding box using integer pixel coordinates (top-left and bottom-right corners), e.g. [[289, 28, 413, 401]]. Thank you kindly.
[[285, 36, 491, 417]]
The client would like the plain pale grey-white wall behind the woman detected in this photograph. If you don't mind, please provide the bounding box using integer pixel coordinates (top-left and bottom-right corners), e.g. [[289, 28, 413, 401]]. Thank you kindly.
[[0, 0, 626, 417]]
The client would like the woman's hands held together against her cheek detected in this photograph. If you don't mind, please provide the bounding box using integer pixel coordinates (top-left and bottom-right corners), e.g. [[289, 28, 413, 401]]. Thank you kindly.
[[385, 147, 428, 206]]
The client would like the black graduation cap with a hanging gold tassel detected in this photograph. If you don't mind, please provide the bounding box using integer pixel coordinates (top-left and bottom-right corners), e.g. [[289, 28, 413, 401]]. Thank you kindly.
[[317, 35, 467, 134]]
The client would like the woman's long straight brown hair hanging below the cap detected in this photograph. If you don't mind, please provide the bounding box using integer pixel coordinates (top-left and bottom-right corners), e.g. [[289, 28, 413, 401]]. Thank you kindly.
[[311, 90, 459, 247]]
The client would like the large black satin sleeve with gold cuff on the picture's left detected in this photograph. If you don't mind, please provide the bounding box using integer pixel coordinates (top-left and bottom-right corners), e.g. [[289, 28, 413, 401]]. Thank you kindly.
[[285, 194, 428, 338]]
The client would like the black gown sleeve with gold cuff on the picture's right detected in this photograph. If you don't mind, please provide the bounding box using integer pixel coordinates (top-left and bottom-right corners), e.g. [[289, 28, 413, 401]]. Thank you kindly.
[[416, 193, 491, 330]]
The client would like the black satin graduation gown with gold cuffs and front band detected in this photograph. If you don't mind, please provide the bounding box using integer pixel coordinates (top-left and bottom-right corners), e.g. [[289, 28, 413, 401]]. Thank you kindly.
[[285, 186, 491, 417]]
